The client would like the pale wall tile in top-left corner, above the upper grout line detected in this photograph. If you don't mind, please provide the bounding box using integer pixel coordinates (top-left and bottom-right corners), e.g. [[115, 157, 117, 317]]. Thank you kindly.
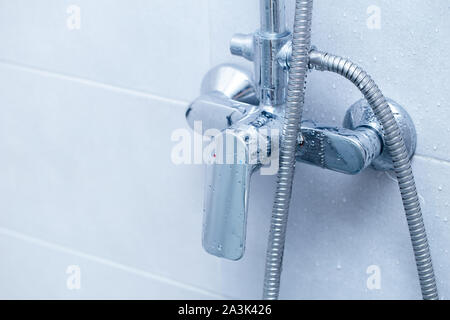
[[0, 0, 209, 100]]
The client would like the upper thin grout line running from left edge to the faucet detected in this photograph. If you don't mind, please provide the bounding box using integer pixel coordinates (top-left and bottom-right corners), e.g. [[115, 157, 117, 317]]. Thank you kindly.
[[0, 59, 188, 106]]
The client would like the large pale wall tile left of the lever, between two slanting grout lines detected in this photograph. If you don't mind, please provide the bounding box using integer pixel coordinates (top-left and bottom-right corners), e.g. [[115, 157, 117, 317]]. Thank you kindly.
[[0, 66, 227, 298]]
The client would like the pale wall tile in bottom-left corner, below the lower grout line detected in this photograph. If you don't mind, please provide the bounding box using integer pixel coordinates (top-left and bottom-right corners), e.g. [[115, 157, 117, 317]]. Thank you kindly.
[[0, 229, 222, 300]]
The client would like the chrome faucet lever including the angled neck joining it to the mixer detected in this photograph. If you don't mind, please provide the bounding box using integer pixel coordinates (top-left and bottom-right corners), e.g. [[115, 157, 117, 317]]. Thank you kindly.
[[202, 111, 277, 260]]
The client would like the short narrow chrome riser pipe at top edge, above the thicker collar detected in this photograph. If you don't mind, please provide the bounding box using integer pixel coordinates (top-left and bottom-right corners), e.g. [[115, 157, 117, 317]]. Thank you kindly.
[[260, 0, 287, 33]]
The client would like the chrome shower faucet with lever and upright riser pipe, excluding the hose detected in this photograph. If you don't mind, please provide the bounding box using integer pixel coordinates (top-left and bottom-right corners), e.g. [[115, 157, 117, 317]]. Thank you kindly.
[[186, 1, 416, 260]]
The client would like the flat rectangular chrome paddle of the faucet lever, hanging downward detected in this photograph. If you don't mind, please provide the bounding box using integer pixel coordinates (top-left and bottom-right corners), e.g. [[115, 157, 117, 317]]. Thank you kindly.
[[202, 134, 255, 260]]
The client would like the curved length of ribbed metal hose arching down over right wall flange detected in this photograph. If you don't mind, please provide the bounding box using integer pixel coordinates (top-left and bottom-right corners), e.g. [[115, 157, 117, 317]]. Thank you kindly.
[[310, 50, 439, 300]]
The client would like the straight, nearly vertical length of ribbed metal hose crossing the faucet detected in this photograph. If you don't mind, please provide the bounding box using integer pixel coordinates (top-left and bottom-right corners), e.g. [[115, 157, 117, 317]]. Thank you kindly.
[[263, 0, 313, 300]]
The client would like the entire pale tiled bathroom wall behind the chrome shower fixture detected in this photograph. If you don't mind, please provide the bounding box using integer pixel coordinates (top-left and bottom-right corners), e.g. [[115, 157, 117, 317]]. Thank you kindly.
[[0, 0, 450, 299]]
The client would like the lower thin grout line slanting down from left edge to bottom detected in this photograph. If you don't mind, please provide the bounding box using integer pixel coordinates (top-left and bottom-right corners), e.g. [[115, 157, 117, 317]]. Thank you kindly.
[[0, 227, 229, 299]]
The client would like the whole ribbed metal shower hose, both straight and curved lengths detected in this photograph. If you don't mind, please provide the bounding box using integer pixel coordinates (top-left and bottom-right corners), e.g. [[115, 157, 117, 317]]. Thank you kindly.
[[263, 0, 439, 300]]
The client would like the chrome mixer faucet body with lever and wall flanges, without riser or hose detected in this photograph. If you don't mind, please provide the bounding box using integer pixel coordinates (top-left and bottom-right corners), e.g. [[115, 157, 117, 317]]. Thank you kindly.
[[186, 64, 417, 260]]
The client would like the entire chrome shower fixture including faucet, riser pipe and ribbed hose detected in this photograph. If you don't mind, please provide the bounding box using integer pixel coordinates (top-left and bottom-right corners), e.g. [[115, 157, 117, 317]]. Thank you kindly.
[[186, 0, 438, 299]]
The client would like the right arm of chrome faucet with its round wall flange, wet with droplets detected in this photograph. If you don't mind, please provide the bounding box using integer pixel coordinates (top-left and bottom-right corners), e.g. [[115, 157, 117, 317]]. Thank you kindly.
[[297, 99, 417, 174]]
